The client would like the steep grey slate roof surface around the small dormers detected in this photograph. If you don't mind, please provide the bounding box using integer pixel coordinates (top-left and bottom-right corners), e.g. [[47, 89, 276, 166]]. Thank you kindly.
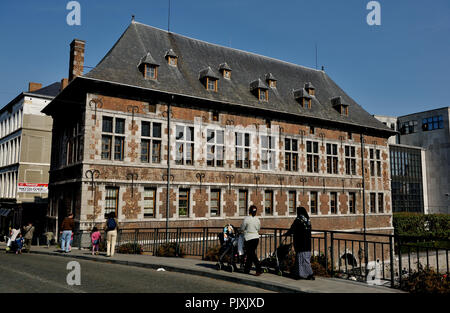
[[85, 22, 391, 131]]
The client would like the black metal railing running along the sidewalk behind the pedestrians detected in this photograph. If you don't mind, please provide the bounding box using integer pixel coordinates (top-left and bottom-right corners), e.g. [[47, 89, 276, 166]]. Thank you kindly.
[[73, 227, 449, 287]]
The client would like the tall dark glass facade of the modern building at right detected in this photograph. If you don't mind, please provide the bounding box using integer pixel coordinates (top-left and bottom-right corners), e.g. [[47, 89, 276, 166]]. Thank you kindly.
[[389, 145, 424, 213]]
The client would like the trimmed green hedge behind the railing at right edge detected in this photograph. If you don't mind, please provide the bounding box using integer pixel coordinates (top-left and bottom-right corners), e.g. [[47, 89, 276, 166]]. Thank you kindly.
[[393, 213, 450, 240]]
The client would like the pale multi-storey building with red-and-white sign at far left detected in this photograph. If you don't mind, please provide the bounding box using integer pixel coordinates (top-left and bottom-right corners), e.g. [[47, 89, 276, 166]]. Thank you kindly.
[[0, 83, 60, 233]]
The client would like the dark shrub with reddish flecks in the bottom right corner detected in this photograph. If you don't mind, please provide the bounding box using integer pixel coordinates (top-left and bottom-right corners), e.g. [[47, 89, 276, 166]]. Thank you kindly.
[[400, 265, 450, 294]]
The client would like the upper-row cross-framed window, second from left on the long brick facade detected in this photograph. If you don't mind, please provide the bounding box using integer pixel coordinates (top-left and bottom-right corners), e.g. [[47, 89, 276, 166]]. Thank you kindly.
[[141, 121, 161, 163]]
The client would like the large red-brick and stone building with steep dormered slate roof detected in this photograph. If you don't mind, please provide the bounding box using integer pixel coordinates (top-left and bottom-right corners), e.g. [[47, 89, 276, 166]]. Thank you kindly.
[[43, 21, 395, 244]]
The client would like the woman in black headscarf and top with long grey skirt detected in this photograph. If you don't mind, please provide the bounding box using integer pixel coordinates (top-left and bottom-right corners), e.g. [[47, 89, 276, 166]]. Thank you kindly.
[[282, 207, 315, 280]]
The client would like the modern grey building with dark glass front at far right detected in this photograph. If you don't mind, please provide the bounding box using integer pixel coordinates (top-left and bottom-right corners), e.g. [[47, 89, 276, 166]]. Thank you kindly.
[[375, 107, 450, 214]]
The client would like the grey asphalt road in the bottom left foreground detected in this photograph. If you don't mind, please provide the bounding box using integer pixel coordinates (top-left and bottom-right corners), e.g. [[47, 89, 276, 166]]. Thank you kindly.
[[0, 251, 268, 293]]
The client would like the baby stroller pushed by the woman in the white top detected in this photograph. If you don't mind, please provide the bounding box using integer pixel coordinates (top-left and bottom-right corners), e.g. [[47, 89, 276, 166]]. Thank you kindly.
[[216, 225, 243, 272]]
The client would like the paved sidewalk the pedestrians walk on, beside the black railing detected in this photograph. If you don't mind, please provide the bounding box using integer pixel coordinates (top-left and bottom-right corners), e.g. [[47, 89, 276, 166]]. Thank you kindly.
[[0, 243, 403, 293]]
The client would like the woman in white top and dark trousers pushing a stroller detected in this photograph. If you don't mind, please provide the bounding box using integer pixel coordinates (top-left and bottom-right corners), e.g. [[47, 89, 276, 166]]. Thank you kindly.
[[240, 205, 262, 276]]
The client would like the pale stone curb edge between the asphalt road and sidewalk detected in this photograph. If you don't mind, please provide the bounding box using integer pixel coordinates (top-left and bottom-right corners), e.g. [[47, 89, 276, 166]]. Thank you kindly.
[[30, 250, 306, 293]]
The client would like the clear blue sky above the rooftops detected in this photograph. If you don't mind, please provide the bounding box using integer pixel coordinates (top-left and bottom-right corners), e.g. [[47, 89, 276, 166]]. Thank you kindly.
[[0, 0, 450, 116]]
